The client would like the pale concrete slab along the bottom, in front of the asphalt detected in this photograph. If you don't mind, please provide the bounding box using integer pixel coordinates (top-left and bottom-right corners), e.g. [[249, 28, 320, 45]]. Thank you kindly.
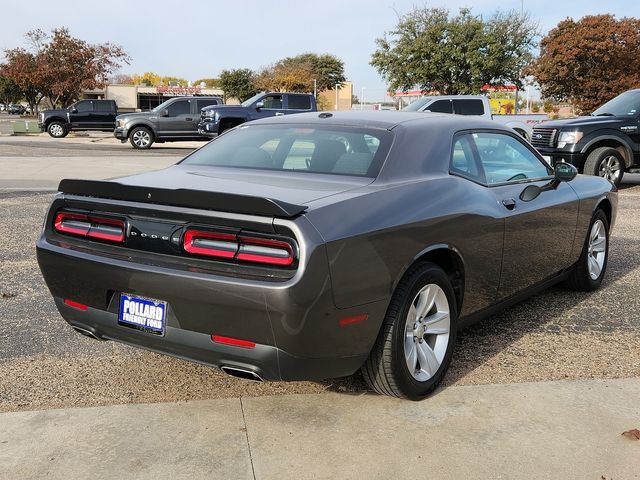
[[0, 378, 640, 480]]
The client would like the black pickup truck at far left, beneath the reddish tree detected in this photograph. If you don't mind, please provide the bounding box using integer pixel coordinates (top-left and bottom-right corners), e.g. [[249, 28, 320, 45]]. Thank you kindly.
[[38, 100, 118, 138]]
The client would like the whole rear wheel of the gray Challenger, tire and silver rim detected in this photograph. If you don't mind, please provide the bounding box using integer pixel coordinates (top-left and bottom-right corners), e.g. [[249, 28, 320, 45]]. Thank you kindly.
[[362, 263, 457, 400]]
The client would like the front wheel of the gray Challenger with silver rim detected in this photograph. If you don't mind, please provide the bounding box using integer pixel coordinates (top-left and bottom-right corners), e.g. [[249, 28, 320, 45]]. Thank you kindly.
[[566, 209, 609, 292]]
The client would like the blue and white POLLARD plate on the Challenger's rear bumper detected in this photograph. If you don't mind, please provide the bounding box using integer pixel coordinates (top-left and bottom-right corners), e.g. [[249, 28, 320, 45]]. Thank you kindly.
[[118, 293, 167, 335]]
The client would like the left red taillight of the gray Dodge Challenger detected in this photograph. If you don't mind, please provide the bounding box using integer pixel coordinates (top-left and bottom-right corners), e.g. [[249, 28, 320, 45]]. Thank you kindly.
[[53, 212, 125, 243]]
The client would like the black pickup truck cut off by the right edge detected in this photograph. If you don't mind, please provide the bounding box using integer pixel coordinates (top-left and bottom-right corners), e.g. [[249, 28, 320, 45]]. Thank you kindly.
[[532, 89, 640, 185]]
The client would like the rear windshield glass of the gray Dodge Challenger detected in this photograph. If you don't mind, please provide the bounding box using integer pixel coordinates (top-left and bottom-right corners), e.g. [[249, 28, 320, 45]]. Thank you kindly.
[[182, 124, 392, 177]]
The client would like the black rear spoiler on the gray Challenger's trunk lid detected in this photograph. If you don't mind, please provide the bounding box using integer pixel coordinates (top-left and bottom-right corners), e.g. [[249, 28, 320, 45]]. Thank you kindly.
[[58, 179, 307, 218]]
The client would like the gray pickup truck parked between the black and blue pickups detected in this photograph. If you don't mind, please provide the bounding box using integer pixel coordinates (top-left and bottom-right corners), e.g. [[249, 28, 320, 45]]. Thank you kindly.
[[113, 97, 224, 149]]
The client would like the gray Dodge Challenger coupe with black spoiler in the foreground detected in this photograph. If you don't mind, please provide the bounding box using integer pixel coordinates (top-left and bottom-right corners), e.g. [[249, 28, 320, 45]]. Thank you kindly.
[[37, 112, 617, 400]]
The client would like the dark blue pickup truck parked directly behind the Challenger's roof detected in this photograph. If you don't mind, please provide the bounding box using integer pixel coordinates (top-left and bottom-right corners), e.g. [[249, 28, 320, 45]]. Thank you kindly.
[[198, 92, 318, 137]]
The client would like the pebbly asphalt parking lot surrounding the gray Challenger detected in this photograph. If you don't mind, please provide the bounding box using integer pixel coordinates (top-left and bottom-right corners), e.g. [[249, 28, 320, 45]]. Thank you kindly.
[[0, 135, 640, 411]]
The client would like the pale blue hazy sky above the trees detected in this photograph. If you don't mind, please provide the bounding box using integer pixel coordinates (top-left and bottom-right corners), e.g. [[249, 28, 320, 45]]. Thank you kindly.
[[0, 0, 640, 101]]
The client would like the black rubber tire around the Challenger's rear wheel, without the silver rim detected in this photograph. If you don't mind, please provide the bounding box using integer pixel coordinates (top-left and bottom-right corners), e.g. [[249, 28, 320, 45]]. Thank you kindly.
[[362, 263, 458, 400]]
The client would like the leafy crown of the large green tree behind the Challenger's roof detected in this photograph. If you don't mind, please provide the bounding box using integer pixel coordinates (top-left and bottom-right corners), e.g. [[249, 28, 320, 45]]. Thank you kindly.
[[371, 7, 538, 95]]
